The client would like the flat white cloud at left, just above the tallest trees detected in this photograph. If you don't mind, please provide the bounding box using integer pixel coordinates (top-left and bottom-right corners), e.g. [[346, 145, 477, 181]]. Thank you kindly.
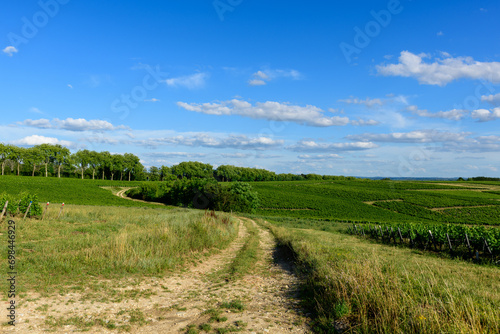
[[20, 118, 128, 131]]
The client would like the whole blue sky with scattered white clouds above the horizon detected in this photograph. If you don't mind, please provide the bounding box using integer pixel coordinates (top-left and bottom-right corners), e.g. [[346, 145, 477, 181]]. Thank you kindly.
[[0, 0, 500, 177]]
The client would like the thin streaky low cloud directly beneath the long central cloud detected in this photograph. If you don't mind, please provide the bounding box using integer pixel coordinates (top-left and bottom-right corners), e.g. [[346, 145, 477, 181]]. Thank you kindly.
[[136, 133, 284, 150]]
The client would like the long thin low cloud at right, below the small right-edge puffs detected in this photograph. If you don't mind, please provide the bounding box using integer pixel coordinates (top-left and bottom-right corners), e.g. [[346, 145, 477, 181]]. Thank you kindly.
[[346, 130, 470, 143]]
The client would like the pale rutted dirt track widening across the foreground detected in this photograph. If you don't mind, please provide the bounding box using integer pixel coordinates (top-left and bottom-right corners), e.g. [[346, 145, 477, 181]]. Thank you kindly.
[[10, 219, 310, 334]]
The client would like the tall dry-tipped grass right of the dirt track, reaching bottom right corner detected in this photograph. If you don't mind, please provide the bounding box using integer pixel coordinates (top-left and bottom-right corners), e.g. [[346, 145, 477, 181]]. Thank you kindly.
[[269, 220, 500, 333]]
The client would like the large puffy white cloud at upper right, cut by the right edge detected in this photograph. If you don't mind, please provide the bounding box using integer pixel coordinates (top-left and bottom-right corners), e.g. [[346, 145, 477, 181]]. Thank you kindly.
[[376, 51, 500, 86]]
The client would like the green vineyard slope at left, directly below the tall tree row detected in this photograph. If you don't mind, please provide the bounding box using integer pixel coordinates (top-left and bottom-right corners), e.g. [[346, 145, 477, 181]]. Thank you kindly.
[[0, 176, 168, 207]]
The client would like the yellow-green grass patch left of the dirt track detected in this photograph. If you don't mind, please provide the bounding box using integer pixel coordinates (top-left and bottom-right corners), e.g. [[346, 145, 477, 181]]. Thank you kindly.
[[0, 206, 237, 290]]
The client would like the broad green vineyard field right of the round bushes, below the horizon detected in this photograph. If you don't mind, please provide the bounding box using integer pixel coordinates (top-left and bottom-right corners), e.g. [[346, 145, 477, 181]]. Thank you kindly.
[[252, 180, 500, 225]]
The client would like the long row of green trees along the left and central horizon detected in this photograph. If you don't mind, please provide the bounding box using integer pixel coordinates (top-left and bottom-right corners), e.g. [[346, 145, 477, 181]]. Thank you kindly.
[[0, 143, 360, 182]]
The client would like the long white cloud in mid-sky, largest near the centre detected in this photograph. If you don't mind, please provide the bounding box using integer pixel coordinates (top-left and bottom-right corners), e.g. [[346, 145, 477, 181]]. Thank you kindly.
[[177, 99, 349, 127]]
